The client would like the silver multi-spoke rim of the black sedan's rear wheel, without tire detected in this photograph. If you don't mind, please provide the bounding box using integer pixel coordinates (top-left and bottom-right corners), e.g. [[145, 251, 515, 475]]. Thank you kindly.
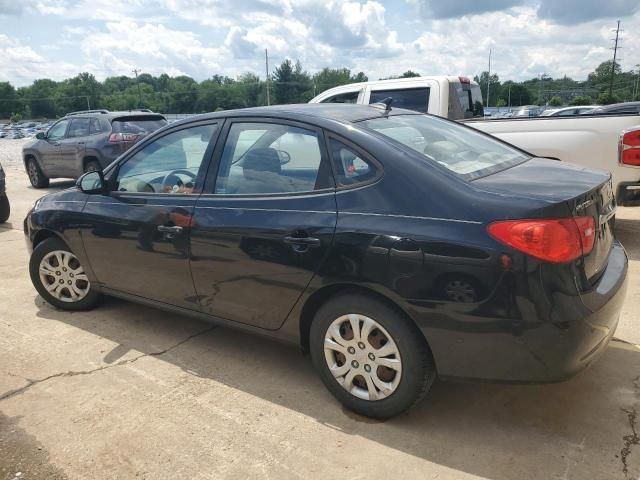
[[324, 313, 402, 401]]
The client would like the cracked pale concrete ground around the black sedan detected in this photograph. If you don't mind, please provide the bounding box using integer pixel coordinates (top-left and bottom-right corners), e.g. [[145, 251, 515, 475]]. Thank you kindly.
[[0, 140, 640, 480]]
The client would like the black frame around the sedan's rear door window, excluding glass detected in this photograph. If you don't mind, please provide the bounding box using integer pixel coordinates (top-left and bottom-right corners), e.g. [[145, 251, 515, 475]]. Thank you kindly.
[[202, 117, 335, 198]]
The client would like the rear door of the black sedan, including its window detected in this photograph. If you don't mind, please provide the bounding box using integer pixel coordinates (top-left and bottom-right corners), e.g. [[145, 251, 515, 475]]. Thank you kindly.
[[191, 120, 336, 330]]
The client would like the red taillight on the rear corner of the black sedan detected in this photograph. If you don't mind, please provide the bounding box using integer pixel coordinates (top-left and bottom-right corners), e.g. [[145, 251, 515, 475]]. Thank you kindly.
[[487, 217, 596, 263]]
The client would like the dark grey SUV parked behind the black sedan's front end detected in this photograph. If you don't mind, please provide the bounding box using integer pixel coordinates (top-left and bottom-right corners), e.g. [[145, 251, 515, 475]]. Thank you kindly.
[[22, 110, 167, 188]]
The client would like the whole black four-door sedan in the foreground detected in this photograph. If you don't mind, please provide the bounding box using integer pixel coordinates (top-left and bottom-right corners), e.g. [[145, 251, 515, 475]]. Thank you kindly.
[[24, 104, 627, 417]]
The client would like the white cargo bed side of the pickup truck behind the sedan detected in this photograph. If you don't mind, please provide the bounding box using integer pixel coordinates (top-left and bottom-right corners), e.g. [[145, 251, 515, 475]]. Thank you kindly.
[[462, 114, 640, 206]]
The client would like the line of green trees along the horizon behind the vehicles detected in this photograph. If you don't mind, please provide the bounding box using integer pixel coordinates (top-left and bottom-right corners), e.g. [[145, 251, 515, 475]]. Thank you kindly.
[[0, 59, 640, 119]]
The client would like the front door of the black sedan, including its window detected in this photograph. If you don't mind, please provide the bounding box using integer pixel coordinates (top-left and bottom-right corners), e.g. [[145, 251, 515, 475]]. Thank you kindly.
[[82, 122, 217, 310]]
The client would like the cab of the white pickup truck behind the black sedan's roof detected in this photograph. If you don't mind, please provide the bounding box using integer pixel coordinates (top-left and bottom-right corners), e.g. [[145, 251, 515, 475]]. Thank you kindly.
[[309, 76, 484, 120]]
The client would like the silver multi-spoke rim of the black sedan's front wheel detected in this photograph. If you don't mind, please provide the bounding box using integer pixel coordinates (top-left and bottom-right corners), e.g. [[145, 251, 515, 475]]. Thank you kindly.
[[39, 250, 91, 303]]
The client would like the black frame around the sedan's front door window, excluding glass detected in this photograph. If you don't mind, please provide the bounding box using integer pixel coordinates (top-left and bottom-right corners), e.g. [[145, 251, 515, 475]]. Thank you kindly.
[[107, 118, 224, 198]]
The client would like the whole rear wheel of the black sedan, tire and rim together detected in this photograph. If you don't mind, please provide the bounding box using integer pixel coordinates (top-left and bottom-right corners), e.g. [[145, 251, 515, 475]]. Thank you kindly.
[[309, 294, 436, 418]]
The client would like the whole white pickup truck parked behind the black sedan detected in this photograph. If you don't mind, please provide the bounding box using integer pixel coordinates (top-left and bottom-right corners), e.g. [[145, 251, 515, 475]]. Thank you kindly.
[[310, 76, 640, 206]]
